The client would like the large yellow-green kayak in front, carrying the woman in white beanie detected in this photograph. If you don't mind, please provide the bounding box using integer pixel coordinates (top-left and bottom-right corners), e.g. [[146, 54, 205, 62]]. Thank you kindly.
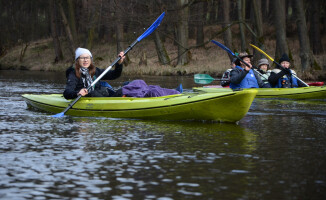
[[23, 90, 257, 122]]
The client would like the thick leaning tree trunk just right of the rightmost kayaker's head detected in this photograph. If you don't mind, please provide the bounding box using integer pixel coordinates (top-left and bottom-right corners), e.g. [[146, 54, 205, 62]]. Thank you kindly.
[[293, 0, 313, 71]]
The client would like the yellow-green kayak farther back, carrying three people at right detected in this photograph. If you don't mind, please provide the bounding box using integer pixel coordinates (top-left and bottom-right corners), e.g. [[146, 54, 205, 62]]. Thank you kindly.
[[193, 86, 326, 99]]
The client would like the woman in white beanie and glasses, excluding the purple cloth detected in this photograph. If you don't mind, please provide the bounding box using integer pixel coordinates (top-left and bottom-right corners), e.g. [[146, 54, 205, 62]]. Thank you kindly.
[[63, 48, 125, 99]]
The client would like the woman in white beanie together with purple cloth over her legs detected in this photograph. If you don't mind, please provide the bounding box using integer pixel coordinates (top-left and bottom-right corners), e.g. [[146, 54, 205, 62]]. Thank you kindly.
[[63, 48, 183, 99]]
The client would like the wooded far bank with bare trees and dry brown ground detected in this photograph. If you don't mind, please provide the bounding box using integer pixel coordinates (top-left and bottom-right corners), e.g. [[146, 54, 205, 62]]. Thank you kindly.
[[0, 0, 326, 81]]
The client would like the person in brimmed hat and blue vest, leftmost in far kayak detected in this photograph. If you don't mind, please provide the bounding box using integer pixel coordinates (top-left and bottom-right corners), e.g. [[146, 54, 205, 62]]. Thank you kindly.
[[230, 52, 270, 89]]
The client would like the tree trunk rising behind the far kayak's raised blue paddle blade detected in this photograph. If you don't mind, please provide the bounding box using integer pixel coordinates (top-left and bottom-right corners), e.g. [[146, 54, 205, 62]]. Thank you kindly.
[[222, 0, 233, 60]]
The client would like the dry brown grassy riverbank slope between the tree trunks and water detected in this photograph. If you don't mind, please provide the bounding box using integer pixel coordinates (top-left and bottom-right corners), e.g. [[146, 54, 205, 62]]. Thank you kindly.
[[0, 38, 326, 81]]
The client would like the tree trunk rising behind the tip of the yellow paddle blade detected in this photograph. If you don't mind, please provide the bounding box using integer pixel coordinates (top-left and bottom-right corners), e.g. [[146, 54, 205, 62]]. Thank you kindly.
[[252, 0, 265, 60]]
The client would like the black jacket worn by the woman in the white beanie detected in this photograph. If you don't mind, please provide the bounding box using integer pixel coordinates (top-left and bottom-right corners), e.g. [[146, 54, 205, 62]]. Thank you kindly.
[[63, 64, 122, 99]]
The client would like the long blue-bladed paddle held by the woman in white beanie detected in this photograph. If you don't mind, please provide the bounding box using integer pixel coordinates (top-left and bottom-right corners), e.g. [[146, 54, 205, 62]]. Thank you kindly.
[[52, 12, 165, 117]]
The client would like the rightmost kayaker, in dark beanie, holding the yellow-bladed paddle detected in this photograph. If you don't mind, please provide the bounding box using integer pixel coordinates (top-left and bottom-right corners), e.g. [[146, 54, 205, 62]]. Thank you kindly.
[[268, 54, 306, 88]]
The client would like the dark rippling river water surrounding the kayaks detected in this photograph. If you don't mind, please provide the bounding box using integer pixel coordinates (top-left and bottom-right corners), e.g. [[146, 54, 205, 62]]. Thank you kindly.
[[0, 71, 326, 200]]
